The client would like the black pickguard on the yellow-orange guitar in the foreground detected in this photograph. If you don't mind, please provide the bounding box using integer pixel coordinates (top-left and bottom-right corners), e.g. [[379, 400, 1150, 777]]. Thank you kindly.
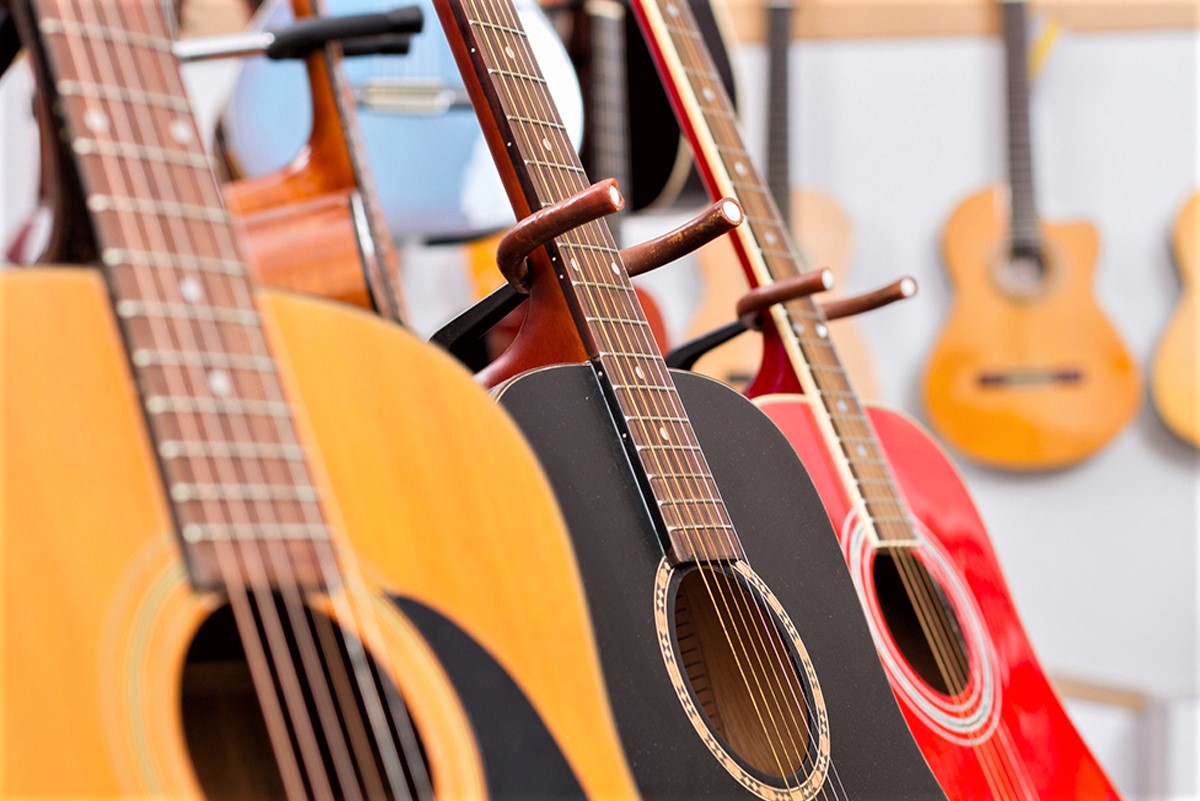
[[391, 596, 586, 801]]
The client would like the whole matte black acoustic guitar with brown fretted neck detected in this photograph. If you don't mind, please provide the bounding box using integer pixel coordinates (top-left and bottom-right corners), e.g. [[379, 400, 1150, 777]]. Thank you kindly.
[[437, 0, 944, 800]]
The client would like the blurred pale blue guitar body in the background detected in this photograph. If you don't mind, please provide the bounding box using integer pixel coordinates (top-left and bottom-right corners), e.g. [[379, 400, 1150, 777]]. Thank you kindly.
[[224, 0, 583, 239]]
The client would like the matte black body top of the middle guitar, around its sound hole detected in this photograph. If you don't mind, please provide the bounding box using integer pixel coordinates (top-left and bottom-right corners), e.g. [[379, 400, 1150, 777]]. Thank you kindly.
[[499, 365, 946, 801]]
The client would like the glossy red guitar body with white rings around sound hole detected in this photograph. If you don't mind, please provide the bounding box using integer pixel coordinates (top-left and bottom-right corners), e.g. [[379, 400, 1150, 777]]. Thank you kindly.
[[755, 395, 1118, 801]]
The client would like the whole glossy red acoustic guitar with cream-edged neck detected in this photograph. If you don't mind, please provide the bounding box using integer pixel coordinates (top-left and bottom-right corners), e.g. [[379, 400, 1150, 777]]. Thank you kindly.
[[635, 0, 1115, 801]]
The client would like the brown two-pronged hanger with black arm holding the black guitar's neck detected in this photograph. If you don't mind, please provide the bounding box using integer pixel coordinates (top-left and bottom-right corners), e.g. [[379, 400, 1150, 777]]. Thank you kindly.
[[430, 179, 745, 371]]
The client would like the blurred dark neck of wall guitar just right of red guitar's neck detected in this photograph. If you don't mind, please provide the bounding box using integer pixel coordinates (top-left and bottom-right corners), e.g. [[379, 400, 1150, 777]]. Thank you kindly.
[[767, 0, 792, 221]]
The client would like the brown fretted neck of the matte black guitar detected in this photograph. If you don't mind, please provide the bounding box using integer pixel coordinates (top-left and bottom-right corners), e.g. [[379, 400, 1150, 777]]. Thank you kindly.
[[437, 0, 742, 562]]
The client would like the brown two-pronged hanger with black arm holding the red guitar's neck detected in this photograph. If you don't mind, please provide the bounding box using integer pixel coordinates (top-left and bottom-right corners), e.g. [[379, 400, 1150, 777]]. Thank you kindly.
[[666, 270, 917, 371]]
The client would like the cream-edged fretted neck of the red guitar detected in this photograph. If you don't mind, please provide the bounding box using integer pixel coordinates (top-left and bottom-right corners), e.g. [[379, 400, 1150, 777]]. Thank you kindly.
[[634, 0, 914, 544]]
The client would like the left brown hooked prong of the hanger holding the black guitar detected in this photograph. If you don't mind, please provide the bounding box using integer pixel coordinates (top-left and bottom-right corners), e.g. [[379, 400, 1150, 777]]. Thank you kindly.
[[496, 177, 625, 295]]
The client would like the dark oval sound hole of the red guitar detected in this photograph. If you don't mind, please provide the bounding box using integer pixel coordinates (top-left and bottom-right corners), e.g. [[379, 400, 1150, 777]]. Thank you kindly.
[[872, 550, 970, 697]]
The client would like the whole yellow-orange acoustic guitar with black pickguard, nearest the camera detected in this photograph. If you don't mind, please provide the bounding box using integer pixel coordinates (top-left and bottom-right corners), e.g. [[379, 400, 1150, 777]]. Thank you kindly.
[[0, 0, 635, 800]]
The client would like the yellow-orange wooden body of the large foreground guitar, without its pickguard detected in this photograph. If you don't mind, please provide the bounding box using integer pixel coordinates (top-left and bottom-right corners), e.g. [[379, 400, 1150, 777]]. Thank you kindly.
[[0, 270, 634, 799]]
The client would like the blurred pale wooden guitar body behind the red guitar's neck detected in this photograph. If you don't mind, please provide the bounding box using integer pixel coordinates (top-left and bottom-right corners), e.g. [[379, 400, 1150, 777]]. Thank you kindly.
[[688, 189, 878, 397]]
